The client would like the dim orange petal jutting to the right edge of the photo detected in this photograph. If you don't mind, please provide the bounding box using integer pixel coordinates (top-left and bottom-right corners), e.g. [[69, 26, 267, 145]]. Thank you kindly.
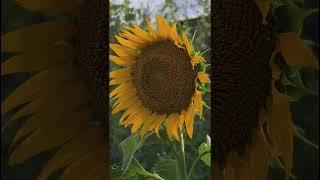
[[278, 32, 319, 68]]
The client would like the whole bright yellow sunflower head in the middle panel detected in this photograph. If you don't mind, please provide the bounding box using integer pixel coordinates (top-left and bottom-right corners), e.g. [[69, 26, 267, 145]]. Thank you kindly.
[[109, 16, 210, 140]]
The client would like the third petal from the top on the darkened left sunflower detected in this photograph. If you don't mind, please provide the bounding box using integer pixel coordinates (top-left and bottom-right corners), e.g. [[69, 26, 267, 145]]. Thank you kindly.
[[1, 47, 76, 75]]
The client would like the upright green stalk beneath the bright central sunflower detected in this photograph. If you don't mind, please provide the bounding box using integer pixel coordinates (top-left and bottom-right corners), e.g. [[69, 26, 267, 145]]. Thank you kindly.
[[177, 132, 188, 180]]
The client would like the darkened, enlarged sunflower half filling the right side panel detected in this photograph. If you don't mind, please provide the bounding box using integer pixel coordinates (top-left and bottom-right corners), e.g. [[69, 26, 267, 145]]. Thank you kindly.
[[212, 0, 317, 180]]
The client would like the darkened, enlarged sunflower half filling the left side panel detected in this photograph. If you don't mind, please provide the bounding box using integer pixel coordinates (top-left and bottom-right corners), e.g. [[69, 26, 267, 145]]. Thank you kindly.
[[1, 0, 108, 180]]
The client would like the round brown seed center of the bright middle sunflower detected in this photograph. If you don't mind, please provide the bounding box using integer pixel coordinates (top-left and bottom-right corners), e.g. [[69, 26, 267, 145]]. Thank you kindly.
[[132, 40, 196, 114]]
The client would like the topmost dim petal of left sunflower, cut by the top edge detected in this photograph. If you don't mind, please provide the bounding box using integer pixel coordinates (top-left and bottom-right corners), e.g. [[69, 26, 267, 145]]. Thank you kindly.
[[16, 0, 80, 13]]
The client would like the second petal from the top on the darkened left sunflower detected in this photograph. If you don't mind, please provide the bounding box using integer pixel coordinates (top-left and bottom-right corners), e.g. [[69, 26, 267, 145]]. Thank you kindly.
[[1, 21, 76, 52]]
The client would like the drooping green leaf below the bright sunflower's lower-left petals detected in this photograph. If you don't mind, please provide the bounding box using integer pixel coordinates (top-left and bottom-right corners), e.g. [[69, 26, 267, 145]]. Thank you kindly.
[[120, 133, 150, 172]]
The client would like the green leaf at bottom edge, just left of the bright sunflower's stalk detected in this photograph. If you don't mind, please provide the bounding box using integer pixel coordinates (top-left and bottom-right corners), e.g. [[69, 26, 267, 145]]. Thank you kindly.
[[155, 159, 178, 180]]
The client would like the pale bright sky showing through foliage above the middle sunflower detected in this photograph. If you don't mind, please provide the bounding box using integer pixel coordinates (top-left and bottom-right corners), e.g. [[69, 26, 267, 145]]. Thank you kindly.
[[112, 0, 210, 20]]
